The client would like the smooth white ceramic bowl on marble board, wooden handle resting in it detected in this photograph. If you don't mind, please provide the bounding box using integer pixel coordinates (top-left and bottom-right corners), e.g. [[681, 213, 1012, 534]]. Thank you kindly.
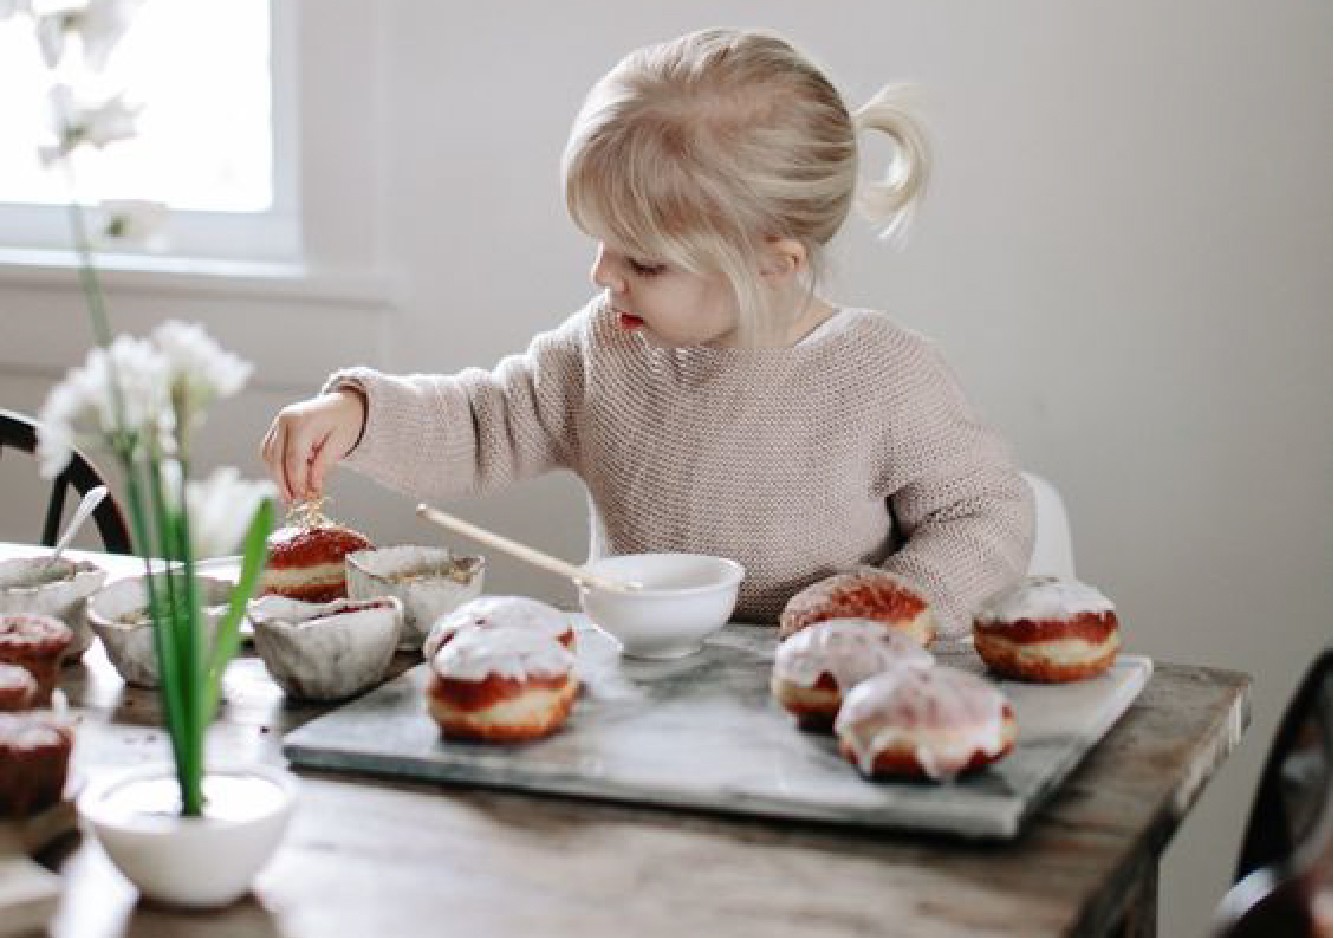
[[579, 554, 746, 658]]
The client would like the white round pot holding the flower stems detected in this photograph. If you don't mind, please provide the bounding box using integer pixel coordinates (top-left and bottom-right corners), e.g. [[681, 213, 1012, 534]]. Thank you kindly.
[[79, 765, 296, 909]]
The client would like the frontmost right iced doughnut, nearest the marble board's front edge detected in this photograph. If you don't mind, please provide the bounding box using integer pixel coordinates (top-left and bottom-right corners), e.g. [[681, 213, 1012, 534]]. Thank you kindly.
[[834, 664, 1017, 781]]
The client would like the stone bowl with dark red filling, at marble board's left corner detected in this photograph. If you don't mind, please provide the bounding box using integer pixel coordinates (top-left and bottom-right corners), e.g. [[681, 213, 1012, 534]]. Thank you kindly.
[[249, 596, 403, 700]]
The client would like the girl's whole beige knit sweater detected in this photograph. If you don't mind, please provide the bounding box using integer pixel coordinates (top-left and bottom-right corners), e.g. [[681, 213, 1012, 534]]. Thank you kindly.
[[327, 302, 1033, 635]]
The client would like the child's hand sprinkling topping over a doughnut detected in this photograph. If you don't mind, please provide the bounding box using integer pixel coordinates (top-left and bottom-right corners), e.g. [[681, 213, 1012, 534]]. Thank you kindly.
[[259, 388, 366, 502]]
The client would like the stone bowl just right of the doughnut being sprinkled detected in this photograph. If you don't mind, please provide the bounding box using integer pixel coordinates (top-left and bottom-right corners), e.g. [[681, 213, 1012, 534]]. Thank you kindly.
[[344, 546, 487, 651]]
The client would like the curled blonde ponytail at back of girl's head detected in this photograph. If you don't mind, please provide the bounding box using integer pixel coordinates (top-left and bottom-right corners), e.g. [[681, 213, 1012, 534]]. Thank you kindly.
[[852, 84, 930, 239]]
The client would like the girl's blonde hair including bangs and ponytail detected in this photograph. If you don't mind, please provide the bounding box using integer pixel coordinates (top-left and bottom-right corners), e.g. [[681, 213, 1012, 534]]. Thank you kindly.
[[562, 29, 927, 344]]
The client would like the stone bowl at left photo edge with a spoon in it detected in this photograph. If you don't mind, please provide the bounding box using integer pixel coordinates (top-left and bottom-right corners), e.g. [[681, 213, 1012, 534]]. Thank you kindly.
[[0, 556, 107, 664]]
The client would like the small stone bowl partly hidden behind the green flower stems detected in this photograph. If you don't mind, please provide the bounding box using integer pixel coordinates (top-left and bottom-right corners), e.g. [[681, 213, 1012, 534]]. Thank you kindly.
[[88, 576, 236, 687]]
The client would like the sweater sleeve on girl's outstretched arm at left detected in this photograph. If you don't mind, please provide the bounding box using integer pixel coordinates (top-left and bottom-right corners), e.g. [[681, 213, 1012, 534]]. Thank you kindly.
[[324, 312, 587, 499]]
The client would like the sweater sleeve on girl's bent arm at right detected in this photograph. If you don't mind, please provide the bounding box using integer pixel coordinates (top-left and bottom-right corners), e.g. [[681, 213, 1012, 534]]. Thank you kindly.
[[882, 336, 1034, 636]]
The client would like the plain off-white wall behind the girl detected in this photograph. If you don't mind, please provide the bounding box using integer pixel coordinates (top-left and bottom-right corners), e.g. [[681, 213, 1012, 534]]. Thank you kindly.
[[0, 0, 1331, 935]]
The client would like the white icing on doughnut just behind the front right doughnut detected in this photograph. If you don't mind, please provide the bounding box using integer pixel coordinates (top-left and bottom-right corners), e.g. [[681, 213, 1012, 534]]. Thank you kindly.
[[774, 619, 935, 694]]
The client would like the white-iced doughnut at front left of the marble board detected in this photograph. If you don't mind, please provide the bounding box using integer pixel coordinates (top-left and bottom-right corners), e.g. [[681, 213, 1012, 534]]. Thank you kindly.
[[427, 628, 579, 742]]
